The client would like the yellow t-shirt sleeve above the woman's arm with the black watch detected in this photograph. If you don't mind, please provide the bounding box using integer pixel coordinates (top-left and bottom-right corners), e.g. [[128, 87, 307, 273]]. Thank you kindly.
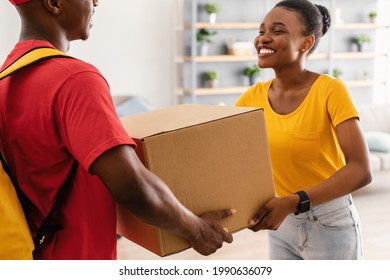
[[327, 79, 359, 127]]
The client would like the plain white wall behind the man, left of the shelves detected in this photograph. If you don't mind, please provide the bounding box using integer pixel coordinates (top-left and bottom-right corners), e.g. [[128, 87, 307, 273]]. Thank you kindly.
[[0, 0, 175, 108]]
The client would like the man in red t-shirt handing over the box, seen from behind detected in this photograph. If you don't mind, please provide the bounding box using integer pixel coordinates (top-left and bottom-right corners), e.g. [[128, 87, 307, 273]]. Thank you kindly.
[[0, 0, 234, 259]]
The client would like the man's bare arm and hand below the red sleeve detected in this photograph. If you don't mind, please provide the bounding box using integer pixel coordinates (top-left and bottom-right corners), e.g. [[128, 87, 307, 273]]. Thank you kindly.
[[90, 145, 234, 255]]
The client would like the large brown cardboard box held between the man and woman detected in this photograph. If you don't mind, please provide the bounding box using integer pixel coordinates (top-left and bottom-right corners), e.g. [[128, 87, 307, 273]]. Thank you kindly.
[[117, 105, 274, 256]]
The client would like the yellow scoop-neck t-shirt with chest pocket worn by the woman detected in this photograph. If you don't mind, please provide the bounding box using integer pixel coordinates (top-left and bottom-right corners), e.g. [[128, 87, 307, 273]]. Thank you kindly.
[[235, 75, 358, 196]]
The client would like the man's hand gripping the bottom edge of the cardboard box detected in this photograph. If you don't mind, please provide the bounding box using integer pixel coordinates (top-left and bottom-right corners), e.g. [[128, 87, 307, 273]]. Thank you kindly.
[[190, 209, 236, 256]]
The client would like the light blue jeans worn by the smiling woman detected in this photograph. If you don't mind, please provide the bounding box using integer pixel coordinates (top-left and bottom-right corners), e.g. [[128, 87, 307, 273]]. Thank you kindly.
[[268, 195, 363, 260]]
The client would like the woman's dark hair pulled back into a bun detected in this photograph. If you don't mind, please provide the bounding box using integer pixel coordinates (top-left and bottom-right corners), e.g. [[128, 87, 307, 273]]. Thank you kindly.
[[275, 0, 331, 54]]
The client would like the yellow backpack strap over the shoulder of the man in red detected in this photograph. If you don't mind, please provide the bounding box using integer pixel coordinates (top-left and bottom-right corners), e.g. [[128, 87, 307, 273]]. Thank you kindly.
[[0, 48, 72, 80]]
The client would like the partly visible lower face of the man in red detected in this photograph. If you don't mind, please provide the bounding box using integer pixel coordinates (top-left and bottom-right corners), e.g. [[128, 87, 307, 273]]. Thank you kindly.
[[59, 0, 99, 41]]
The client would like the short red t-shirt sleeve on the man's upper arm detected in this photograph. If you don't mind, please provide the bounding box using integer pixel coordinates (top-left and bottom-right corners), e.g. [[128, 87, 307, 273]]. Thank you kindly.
[[56, 71, 135, 170]]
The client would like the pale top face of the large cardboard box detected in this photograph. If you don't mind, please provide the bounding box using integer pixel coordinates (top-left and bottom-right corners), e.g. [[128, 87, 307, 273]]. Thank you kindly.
[[121, 104, 261, 139]]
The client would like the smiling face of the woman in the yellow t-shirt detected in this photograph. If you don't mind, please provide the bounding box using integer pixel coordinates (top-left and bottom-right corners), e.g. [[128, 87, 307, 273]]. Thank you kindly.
[[254, 7, 306, 69]]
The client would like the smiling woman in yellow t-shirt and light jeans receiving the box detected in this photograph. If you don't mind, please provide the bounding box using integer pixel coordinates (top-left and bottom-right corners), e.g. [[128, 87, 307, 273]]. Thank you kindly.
[[236, 0, 371, 259]]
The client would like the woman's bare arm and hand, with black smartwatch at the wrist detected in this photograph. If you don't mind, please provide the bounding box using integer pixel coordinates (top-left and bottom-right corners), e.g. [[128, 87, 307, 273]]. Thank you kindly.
[[249, 118, 372, 231]]
